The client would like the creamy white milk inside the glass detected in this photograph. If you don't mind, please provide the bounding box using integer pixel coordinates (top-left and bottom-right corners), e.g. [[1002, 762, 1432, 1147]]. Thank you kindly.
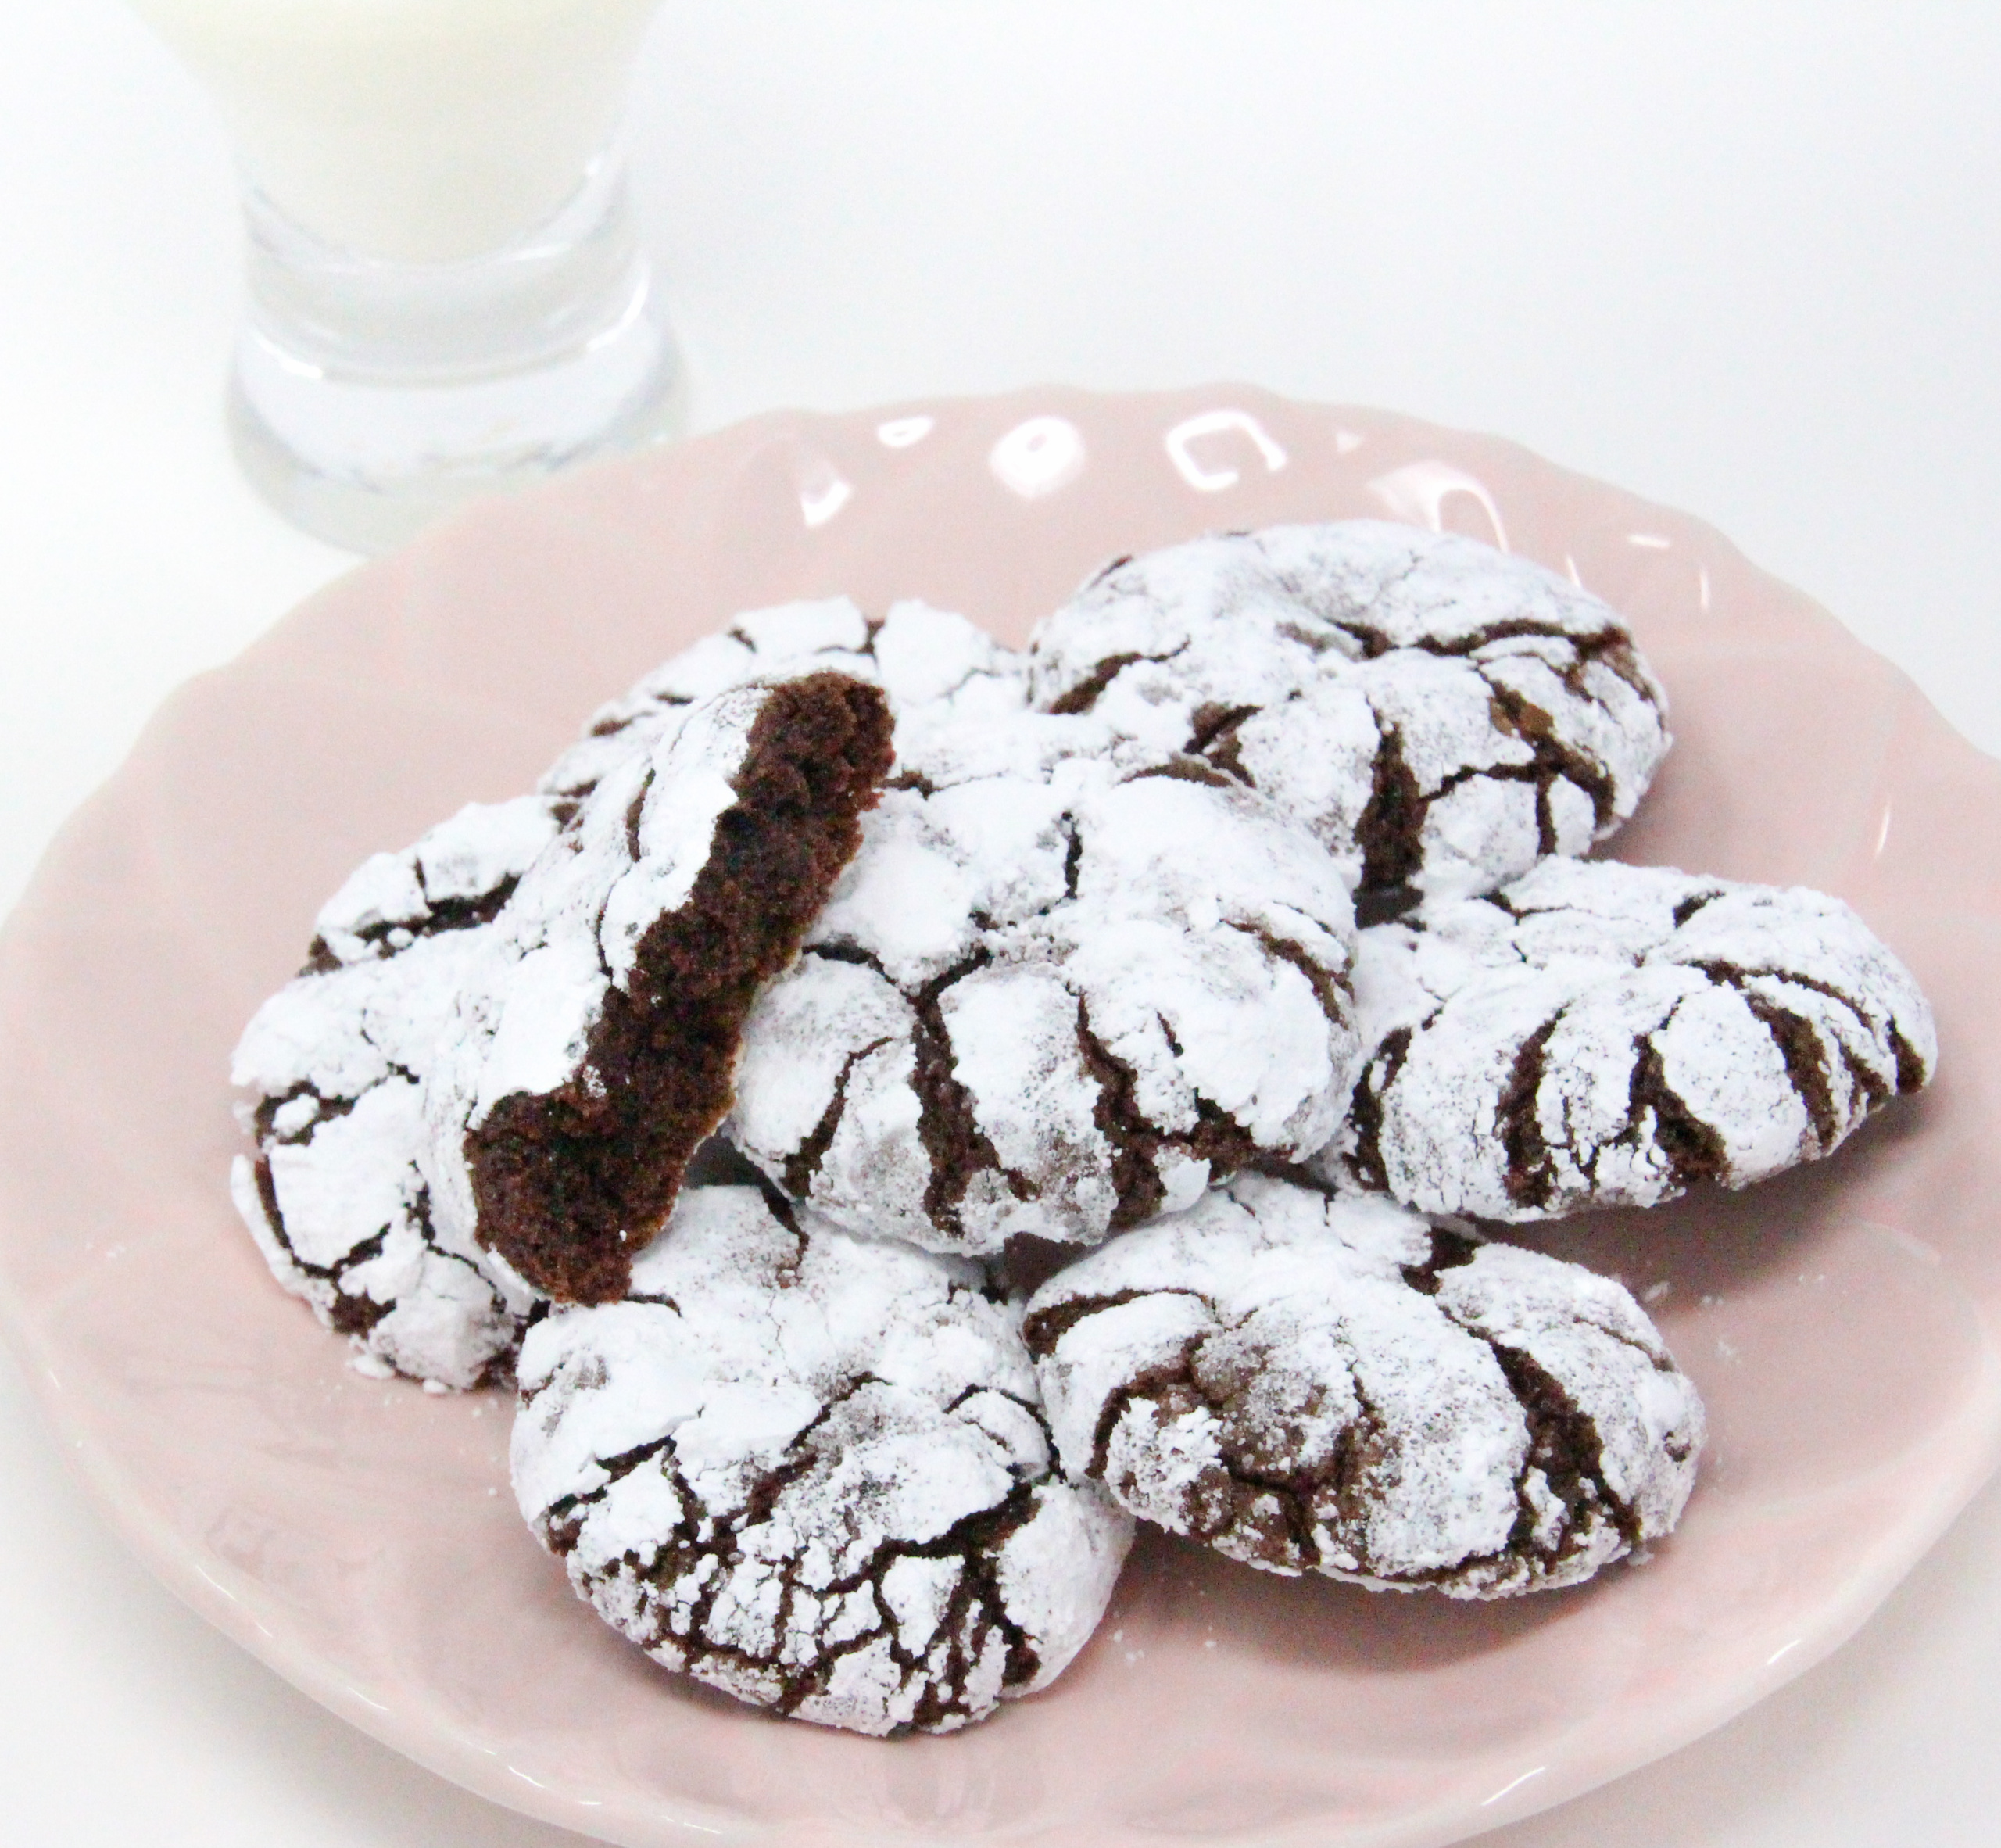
[[132, 0, 660, 264]]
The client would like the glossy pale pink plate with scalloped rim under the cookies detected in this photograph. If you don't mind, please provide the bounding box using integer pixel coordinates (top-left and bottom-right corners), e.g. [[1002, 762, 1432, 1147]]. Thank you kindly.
[[0, 386, 2001, 1848]]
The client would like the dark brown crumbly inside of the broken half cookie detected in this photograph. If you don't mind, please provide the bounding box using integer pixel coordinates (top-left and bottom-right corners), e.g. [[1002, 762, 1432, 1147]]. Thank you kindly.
[[466, 673, 893, 1303]]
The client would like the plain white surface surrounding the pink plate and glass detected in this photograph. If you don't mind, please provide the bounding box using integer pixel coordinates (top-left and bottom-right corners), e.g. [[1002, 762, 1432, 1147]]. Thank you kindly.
[[0, 0, 2001, 1848]]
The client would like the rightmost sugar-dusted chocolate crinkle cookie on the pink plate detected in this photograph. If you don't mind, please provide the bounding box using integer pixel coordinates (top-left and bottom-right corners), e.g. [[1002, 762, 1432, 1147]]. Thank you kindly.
[[1316, 859, 1937, 1219]]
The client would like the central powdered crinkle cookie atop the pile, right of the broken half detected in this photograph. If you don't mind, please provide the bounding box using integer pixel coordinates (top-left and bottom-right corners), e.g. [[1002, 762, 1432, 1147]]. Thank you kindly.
[[730, 713, 1355, 1253]]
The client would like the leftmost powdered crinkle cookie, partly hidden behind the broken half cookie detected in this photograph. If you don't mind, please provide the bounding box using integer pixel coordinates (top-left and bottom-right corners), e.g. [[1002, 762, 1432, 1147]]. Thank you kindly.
[[230, 797, 562, 1388]]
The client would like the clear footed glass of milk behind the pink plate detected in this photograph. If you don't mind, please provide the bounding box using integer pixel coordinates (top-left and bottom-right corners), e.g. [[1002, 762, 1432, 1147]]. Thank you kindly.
[[132, 0, 682, 550]]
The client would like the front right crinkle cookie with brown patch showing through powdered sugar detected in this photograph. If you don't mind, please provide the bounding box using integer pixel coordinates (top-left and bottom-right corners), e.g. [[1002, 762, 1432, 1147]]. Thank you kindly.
[[1026, 1175, 1703, 1598]]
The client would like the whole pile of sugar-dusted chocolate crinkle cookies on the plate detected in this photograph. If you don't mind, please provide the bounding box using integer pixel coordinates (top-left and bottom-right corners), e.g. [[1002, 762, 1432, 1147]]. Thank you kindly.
[[234, 522, 1935, 1734]]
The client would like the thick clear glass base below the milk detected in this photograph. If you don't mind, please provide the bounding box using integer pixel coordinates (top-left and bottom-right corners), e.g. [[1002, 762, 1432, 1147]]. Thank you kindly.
[[228, 158, 686, 553]]
